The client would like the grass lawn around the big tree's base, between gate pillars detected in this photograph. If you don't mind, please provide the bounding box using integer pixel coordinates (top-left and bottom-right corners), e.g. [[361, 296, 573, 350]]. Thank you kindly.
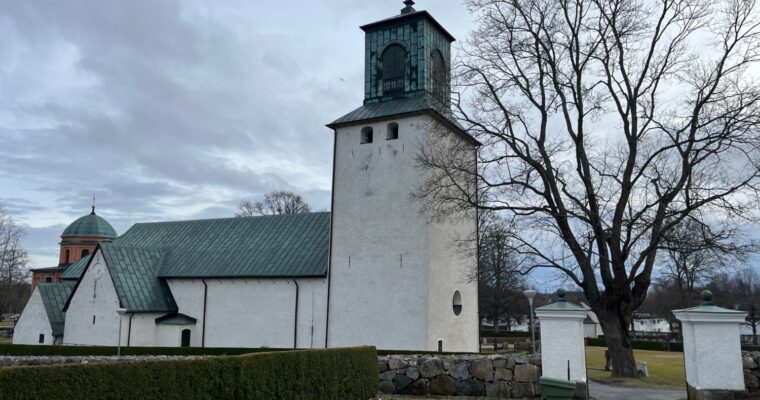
[[586, 346, 686, 389]]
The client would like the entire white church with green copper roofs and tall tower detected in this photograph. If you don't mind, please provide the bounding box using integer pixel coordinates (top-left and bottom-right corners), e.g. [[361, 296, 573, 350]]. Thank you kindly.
[[13, 0, 479, 352]]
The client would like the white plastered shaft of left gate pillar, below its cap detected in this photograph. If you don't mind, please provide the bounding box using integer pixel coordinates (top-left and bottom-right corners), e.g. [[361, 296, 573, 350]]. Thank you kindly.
[[537, 313, 586, 382]]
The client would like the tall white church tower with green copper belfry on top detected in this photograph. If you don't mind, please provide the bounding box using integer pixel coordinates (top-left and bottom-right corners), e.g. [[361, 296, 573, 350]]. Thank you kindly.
[[326, 0, 479, 352]]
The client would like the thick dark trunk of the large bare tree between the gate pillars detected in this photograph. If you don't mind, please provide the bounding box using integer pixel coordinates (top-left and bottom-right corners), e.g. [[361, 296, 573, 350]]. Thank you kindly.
[[597, 310, 637, 378]]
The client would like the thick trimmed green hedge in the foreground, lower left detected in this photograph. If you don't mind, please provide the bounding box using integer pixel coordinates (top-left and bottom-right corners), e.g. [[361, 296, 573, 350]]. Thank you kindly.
[[0, 347, 378, 400]]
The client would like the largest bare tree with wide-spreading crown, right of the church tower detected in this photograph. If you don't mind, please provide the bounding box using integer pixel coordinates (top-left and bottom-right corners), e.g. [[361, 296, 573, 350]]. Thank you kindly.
[[420, 0, 760, 377]]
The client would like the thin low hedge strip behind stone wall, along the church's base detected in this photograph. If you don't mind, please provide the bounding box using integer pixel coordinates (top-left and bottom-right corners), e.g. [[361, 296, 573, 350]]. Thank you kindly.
[[0, 344, 293, 356]]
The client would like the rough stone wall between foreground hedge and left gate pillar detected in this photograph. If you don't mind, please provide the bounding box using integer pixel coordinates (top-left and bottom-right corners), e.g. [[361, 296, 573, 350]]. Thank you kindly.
[[378, 355, 541, 399]]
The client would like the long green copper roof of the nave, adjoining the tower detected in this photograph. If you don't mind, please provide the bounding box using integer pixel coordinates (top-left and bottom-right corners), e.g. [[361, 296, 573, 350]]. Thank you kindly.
[[116, 212, 330, 278]]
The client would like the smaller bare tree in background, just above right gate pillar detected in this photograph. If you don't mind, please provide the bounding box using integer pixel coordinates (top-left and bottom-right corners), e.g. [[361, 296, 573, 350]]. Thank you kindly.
[[660, 216, 755, 308]]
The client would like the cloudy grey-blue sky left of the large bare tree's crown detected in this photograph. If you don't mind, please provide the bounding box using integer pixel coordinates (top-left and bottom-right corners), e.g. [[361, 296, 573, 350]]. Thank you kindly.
[[0, 0, 473, 267]]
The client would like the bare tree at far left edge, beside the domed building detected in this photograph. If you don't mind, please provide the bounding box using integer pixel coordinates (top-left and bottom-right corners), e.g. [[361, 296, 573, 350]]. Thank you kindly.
[[0, 208, 30, 312]]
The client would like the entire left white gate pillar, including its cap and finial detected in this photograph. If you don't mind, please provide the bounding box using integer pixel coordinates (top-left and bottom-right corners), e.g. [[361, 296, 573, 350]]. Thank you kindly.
[[536, 289, 588, 384]]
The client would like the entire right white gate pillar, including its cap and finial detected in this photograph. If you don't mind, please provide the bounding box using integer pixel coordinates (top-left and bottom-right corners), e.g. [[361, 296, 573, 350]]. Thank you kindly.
[[673, 290, 747, 400]]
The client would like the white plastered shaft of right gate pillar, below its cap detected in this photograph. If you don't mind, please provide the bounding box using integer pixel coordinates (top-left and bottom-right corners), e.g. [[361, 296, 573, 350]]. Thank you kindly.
[[682, 322, 744, 391]]
